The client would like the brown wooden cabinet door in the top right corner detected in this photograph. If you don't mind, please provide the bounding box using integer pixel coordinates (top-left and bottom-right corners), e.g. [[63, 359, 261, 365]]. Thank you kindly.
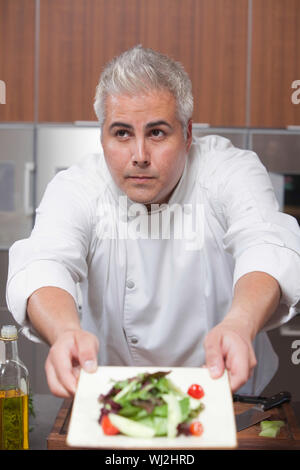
[[250, 0, 300, 128]]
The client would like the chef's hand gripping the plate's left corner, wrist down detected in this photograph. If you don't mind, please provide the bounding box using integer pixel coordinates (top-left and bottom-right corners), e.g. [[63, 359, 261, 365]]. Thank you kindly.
[[45, 329, 99, 398]]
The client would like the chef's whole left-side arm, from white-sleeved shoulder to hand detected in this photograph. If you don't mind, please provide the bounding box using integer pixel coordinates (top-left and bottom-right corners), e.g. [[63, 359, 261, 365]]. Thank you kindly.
[[6, 162, 99, 397]]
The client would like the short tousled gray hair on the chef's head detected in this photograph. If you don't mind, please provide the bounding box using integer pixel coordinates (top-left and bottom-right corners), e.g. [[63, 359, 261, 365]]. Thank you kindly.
[[94, 45, 193, 136]]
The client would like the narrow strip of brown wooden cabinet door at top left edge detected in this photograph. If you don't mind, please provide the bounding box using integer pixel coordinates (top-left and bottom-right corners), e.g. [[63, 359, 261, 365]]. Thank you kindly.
[[0, 0, 35, 122]]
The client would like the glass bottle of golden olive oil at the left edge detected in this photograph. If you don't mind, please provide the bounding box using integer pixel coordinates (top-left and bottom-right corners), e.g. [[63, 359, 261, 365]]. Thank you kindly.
[[0, 325, 29, 450]]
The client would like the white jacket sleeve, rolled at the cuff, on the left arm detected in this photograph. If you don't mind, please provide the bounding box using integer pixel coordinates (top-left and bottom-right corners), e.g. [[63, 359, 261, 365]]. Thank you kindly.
[[6, 169, 91, 341]]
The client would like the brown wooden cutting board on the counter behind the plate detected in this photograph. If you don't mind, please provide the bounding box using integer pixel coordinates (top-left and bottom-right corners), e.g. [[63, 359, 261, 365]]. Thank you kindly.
[[47, 399, 300, 450]]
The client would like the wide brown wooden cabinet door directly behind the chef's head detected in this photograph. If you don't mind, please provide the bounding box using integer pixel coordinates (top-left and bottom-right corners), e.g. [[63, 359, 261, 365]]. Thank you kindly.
[[39, 0, 248, 126]]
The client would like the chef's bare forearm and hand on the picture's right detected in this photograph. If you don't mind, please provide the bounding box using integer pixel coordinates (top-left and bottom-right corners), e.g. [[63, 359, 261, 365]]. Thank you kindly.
[[204, 272, 281, 392]]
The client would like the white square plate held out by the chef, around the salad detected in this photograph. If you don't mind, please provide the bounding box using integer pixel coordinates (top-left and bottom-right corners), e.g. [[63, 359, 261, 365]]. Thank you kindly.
[[66, 366, 237, 450]]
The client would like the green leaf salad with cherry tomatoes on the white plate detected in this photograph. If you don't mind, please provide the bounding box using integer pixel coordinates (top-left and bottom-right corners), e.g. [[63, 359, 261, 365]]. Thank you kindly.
[[98, 371, 204, 438]]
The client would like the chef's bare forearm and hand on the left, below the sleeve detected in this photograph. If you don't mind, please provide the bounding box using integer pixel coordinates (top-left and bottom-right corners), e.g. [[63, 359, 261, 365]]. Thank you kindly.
[[27, 287, 99, 397]]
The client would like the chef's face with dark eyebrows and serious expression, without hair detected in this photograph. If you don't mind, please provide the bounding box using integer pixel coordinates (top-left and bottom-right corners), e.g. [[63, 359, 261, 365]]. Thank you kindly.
[[101, 90, 192, 205]]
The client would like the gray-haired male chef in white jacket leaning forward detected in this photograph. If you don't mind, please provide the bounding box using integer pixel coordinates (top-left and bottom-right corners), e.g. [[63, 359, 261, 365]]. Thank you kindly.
[[7, 46, 300, 397]]
